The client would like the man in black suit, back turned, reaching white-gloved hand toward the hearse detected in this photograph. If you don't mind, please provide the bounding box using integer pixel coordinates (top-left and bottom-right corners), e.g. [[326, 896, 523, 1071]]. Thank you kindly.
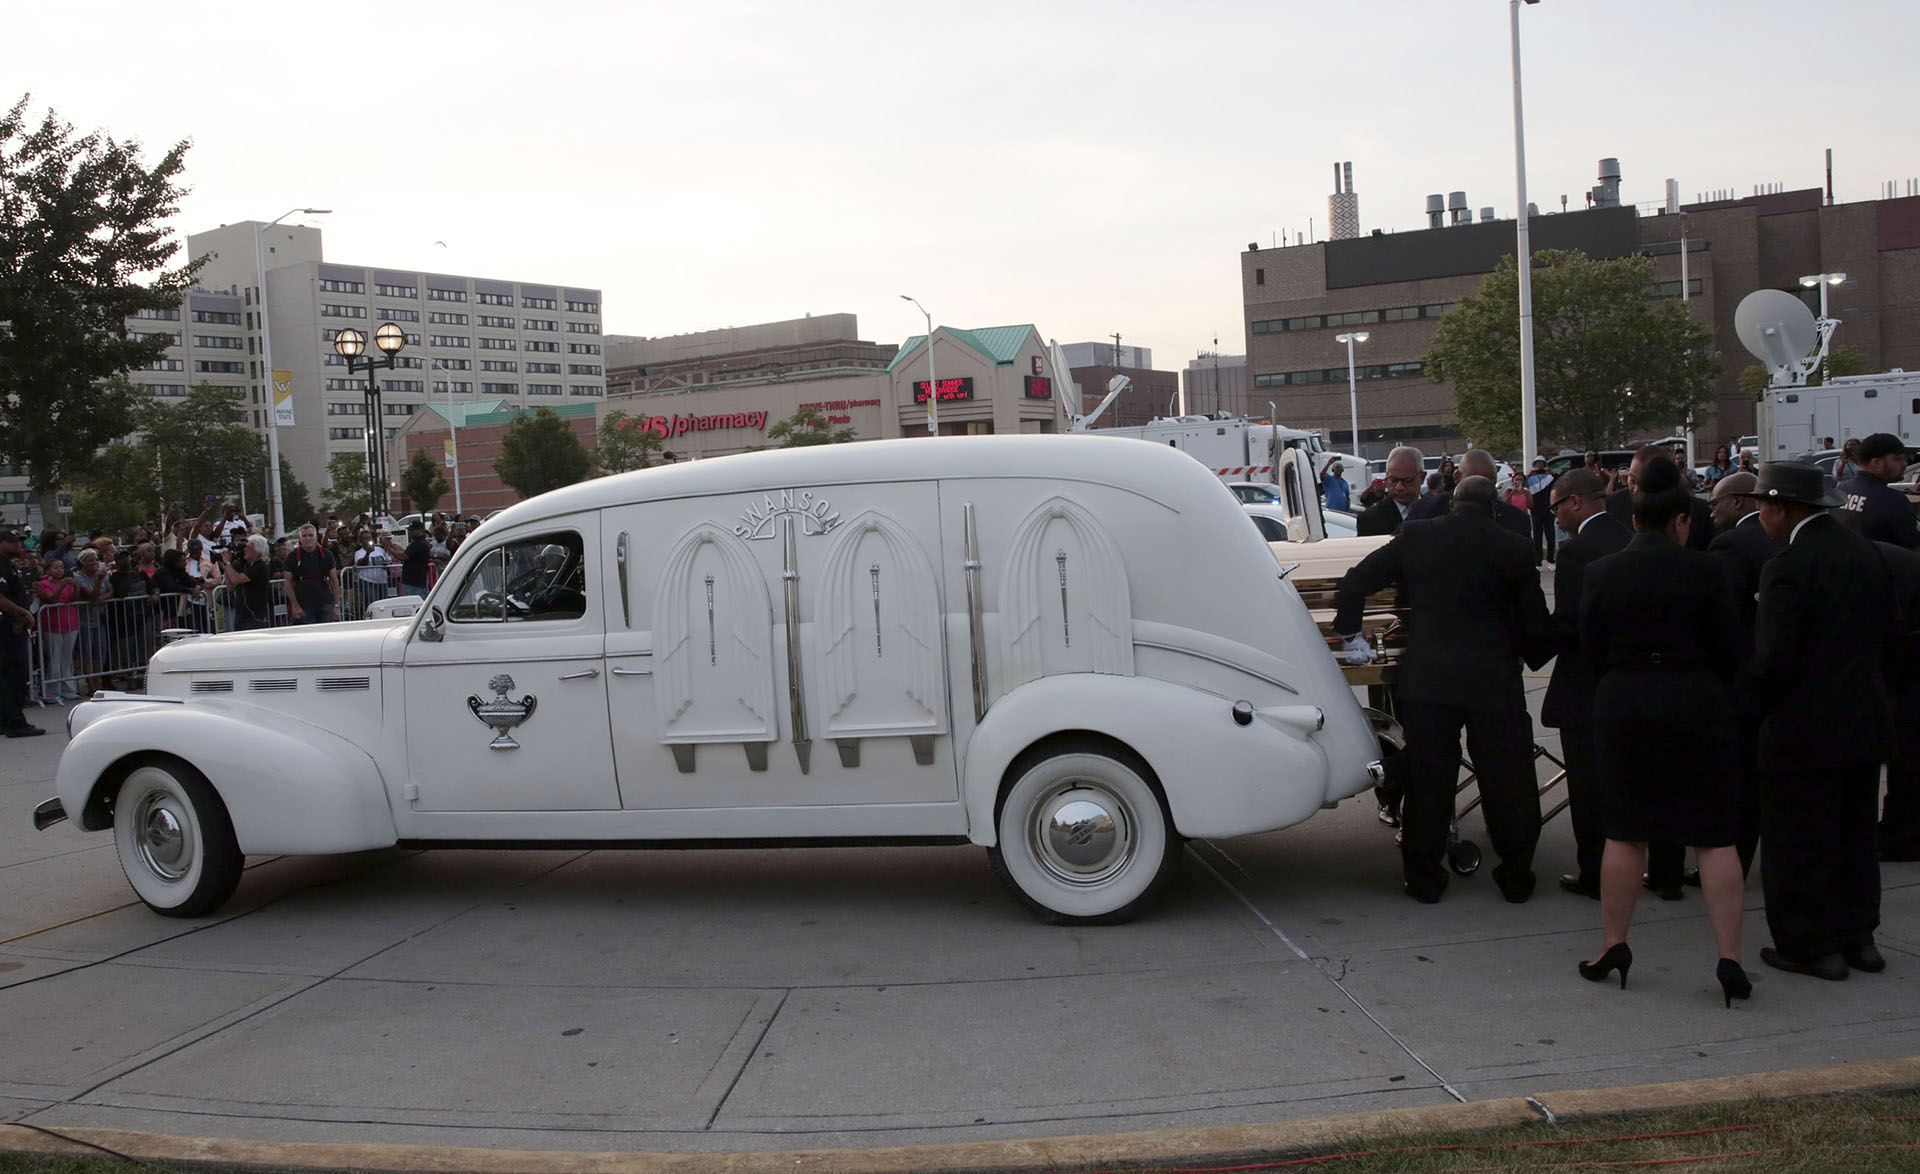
[[1334, 477, 1553, 905]]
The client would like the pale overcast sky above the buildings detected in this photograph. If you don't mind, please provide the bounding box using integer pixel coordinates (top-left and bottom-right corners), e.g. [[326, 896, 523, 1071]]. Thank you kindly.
[[18, 0, 1920, 369]]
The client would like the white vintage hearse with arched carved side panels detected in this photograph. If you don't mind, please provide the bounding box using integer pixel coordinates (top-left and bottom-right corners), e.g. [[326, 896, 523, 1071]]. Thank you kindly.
[[35, 436, 1379, 922]]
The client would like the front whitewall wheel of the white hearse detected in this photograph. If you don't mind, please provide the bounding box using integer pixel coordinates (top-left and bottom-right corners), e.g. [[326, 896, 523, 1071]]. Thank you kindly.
[[113, 759, 242, 917]]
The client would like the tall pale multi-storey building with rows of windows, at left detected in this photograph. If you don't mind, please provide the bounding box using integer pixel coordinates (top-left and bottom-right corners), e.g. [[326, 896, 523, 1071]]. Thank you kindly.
[[186, 221, 607, 503]]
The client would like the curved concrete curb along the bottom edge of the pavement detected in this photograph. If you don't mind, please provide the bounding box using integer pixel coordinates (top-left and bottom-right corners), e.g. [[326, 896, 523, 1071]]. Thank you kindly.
[[0, 1057, 1920, 1174]]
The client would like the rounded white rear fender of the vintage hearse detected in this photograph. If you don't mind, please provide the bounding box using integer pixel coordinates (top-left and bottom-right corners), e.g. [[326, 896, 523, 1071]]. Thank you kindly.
[[964, 674, 1332, 845]]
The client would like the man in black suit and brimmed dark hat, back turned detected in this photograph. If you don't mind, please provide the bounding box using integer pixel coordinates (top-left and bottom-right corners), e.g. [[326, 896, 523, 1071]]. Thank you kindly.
[[1753, 461, 1901, 980]]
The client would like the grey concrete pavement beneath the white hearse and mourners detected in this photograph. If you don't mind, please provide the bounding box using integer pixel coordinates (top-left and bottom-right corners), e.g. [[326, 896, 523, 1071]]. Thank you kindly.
[[0, 664, 1920, 1153]]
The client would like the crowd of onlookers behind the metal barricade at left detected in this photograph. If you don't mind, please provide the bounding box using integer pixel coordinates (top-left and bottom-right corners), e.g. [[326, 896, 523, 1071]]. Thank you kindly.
[[0, 501, 495, 738]]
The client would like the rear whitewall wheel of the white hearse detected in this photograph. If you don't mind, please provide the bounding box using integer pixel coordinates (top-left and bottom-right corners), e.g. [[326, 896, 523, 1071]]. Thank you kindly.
[[987, 742, 1183, 926]]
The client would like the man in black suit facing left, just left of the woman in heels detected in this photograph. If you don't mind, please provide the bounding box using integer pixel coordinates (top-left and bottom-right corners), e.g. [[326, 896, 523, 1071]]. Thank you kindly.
[[1540, 469, 1634, 901]]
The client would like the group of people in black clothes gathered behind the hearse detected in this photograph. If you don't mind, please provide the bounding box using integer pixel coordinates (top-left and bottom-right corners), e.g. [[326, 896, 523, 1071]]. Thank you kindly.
[[1334, 434, 1920, 1005]]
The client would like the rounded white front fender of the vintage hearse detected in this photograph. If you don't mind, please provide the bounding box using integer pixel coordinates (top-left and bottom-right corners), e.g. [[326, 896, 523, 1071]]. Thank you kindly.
[[56, 701, 397, 853]]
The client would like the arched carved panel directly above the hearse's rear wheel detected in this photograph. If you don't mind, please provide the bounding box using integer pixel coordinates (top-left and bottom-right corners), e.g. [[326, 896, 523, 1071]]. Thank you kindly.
[[998, 498, 1133, 692]]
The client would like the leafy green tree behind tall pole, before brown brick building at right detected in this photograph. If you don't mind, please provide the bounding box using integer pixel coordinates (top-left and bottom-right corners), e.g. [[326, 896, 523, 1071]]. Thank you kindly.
[[1427, 250, 1720, 450]]
